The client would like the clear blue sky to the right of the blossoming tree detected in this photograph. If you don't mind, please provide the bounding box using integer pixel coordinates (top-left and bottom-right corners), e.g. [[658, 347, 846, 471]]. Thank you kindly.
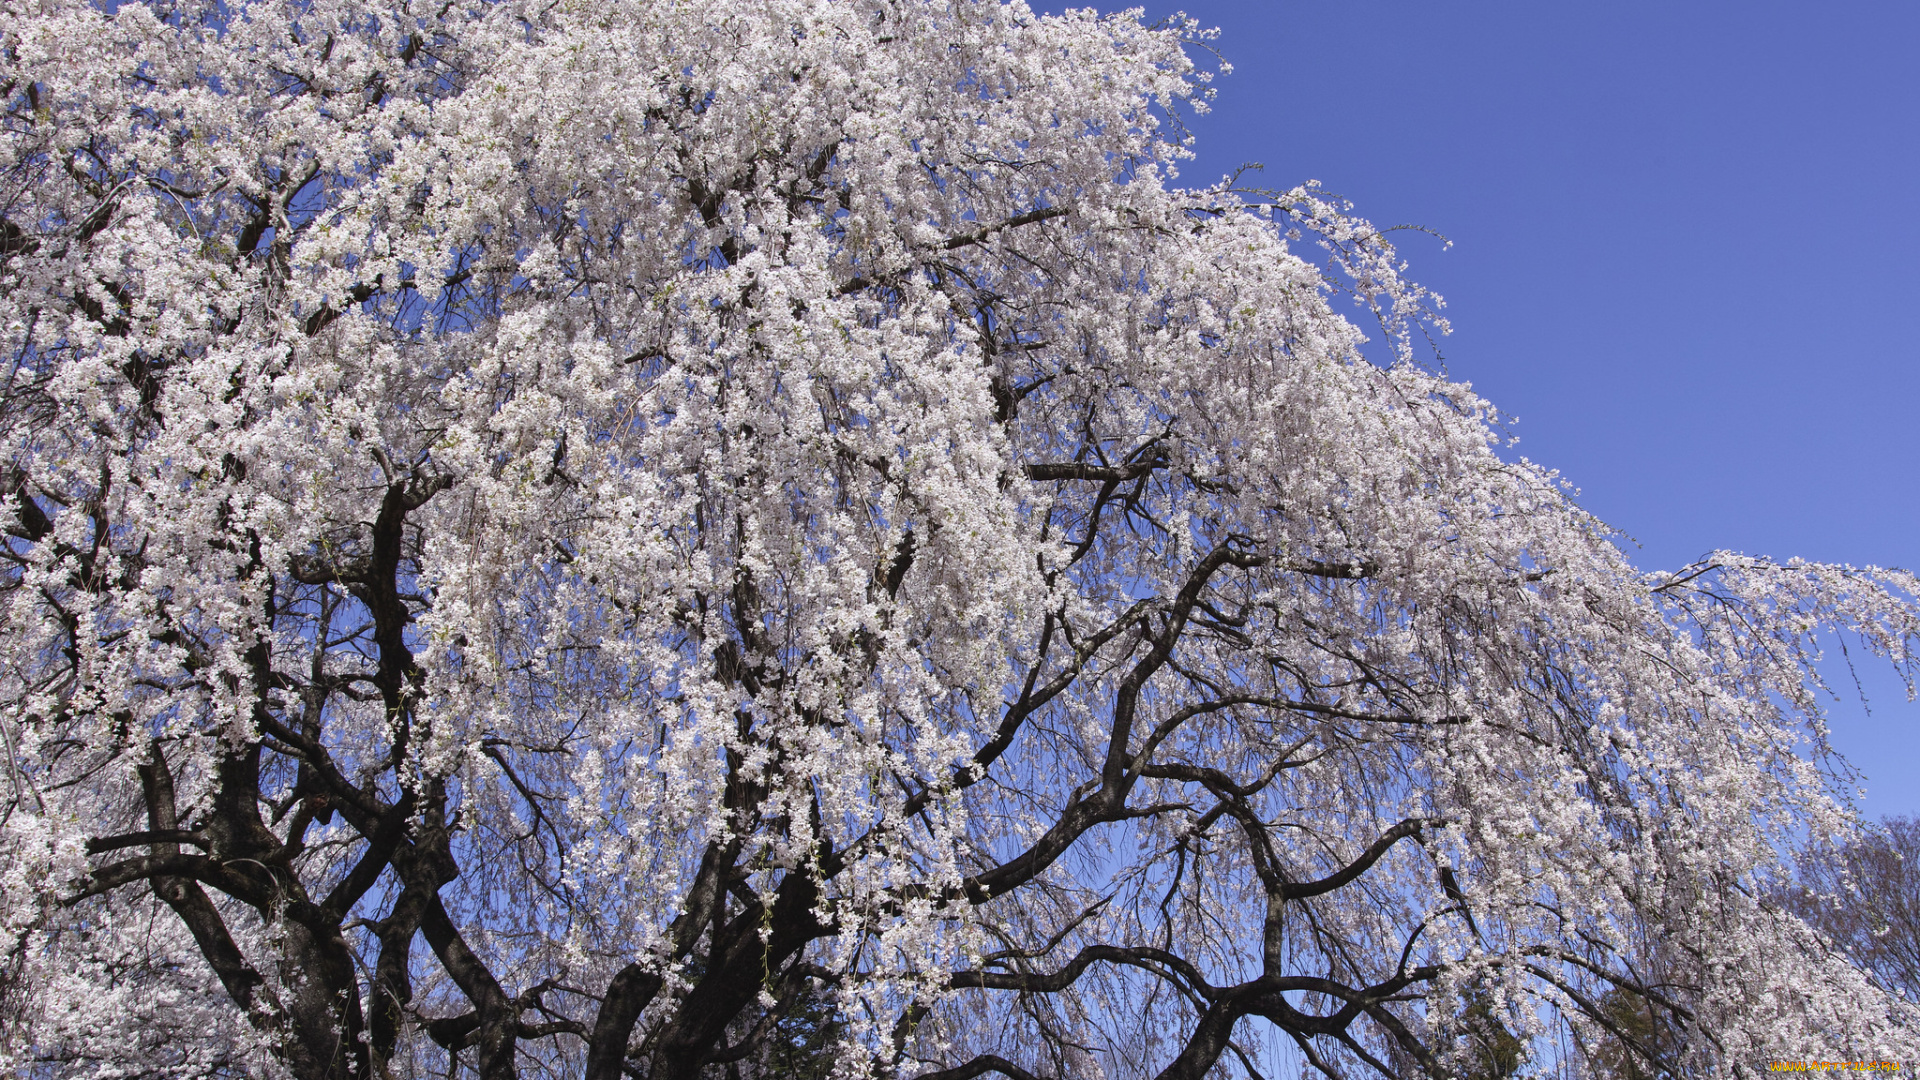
[[1113, 0, 1920, 817]]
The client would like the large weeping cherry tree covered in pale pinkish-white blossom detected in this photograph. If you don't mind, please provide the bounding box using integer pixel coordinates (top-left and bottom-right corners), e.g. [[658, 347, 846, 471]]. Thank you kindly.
[[0, 0, 1920, 1080]]
